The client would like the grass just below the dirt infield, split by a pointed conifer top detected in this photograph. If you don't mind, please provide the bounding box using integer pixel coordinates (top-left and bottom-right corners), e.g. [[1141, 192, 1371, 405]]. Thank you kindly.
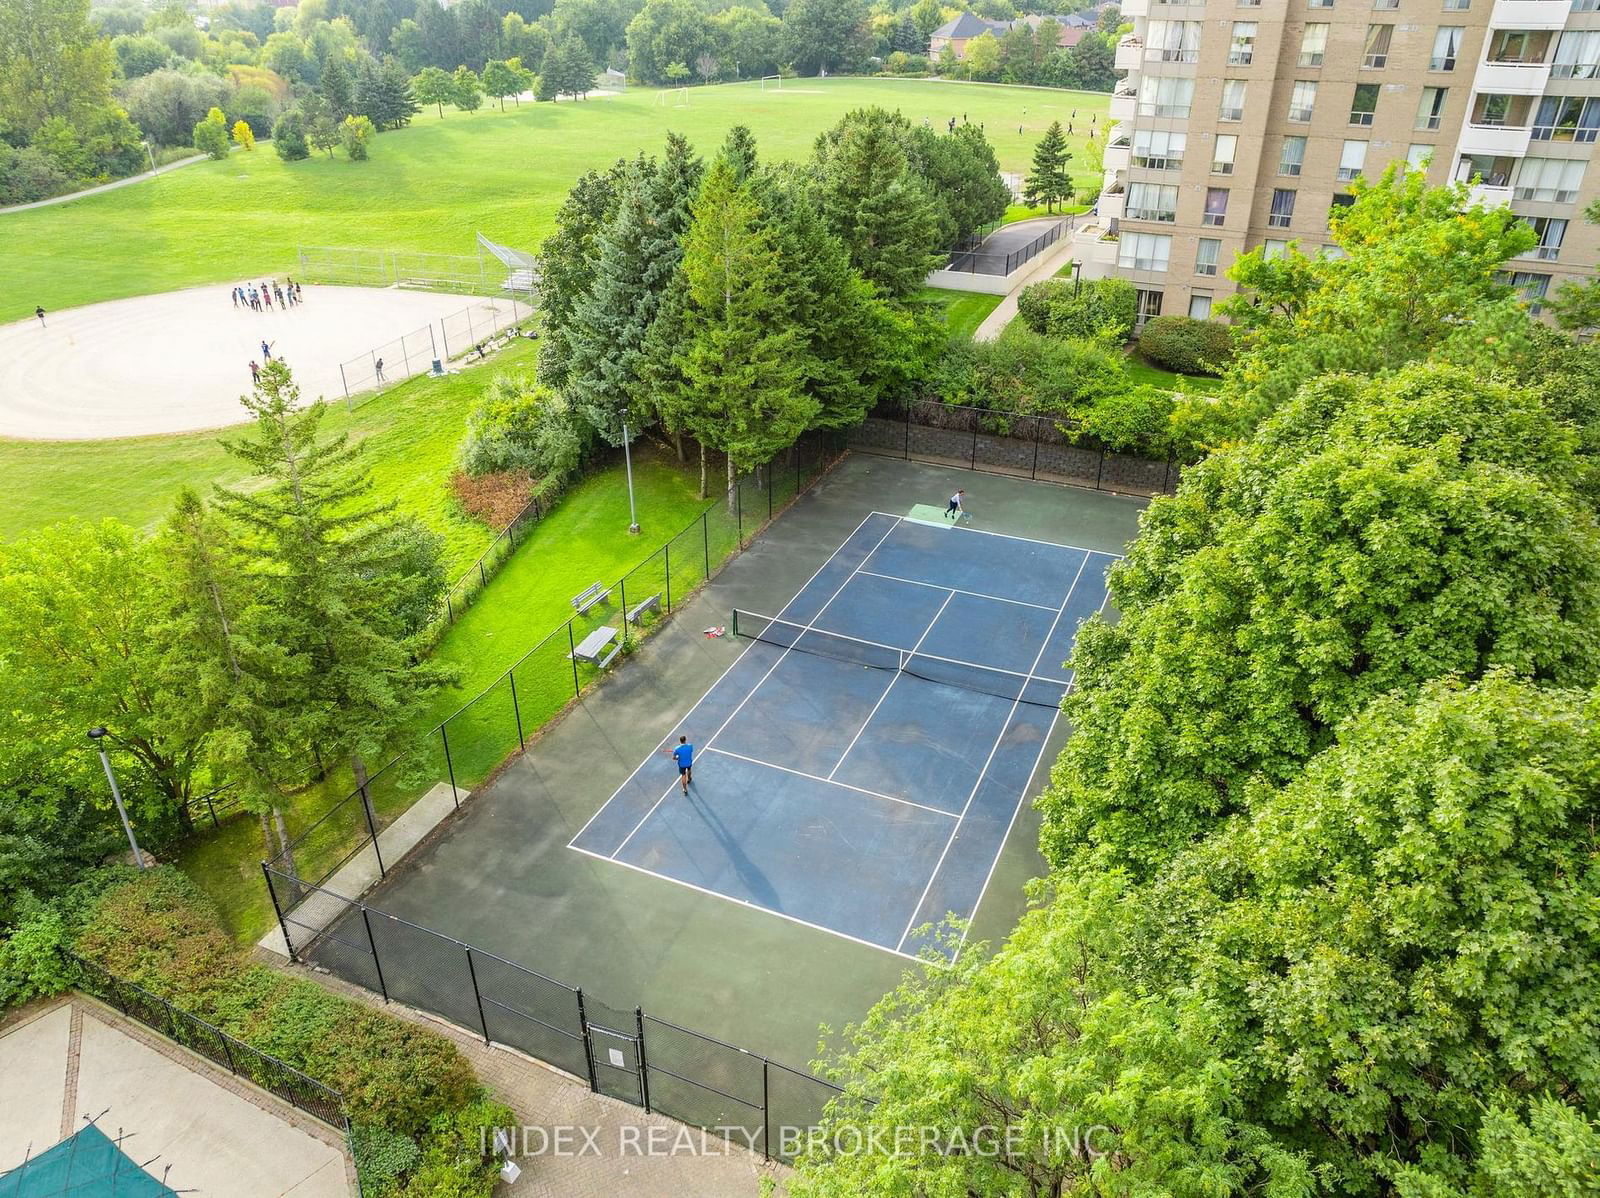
[[0, 341, 536, 577]]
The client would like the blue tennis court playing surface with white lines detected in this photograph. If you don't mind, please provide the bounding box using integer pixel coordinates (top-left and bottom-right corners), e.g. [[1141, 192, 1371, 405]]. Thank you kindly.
[[571, 512, 1117, 955]]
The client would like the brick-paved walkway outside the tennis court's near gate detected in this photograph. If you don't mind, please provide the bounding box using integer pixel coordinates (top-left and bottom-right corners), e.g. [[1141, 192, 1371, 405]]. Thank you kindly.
[[281, 952, 789, 1198]]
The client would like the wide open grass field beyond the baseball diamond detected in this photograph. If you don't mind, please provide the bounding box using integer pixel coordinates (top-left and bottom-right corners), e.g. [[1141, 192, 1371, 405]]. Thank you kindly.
[[0, 78, 1109, 321]]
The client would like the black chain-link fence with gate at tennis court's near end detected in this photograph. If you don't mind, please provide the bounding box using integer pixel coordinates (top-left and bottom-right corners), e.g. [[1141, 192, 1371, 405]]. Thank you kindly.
[[264, 865, 842, 1161]]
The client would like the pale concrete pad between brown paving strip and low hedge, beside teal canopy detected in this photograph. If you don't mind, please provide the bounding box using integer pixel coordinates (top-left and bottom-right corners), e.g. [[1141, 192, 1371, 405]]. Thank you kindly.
[[72, 1006, 349, 1198]]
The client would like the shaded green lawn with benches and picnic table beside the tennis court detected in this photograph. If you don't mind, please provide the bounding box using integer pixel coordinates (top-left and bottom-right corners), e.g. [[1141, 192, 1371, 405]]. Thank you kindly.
[[178, 449, 707, 942]]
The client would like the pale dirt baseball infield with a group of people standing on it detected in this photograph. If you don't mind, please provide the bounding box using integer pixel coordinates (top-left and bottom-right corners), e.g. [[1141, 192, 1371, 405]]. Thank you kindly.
[[0, 280, 485, 440]]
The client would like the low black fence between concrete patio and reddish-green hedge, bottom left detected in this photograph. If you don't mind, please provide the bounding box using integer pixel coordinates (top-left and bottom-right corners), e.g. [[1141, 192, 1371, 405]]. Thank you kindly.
[[62, 950, 350, 1137]]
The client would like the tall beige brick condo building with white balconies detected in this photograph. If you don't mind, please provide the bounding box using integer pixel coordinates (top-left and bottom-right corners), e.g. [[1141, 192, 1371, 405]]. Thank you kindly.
[[1074, 0, 1600, 323]]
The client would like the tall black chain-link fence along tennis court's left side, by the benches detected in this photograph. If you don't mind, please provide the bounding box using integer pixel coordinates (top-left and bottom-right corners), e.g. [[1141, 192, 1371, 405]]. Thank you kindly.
[[267, 433, 842, 916]]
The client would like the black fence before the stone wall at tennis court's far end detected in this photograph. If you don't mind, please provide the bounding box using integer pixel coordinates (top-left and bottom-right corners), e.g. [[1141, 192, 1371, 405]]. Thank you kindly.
[[848, 400, 1182, 496]]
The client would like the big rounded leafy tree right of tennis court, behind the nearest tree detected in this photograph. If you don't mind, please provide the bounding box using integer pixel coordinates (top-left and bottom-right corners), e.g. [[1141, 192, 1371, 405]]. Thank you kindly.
[[1040, 365, 1600, 870]]
